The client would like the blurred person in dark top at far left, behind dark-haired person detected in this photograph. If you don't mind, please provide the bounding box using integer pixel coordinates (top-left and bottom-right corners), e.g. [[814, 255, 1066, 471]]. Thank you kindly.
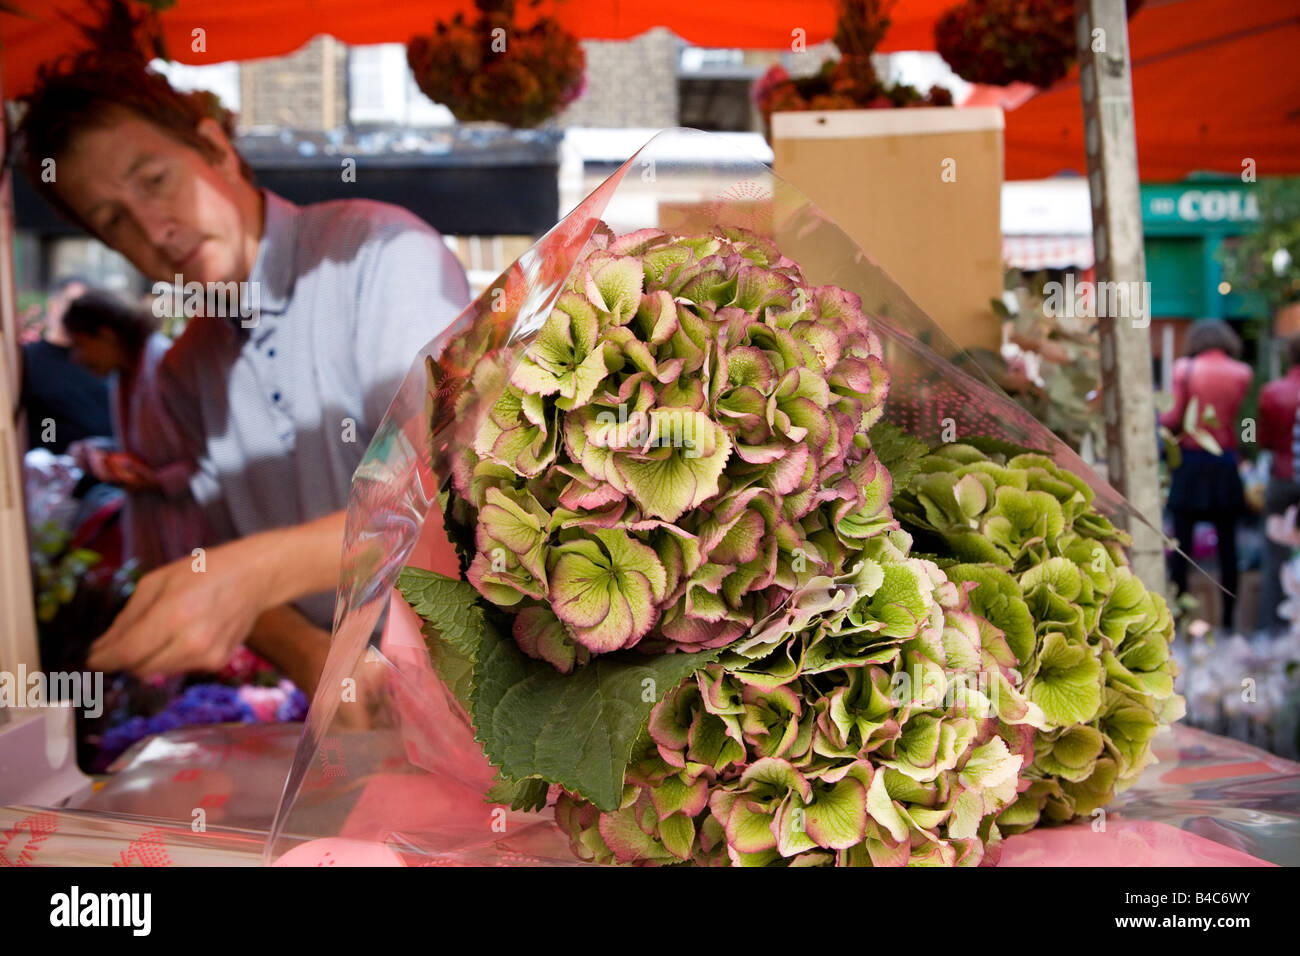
[[18, 276, 113, 455]]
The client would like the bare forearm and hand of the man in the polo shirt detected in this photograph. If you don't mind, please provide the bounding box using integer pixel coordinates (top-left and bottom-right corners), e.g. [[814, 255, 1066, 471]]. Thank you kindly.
[[87, 511, 345, 678]]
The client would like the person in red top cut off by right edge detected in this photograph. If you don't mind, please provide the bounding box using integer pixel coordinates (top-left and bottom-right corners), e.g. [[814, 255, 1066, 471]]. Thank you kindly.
[[1256, 334, 1300, 635]]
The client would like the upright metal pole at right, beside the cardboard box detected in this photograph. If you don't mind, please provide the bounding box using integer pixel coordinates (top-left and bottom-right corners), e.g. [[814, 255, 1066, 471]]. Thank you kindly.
[[1075, 0, 1165, 594]]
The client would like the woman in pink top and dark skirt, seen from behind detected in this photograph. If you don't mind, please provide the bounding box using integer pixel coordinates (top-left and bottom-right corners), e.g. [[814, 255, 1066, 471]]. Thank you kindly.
[[1160, 321, 1255, 631]]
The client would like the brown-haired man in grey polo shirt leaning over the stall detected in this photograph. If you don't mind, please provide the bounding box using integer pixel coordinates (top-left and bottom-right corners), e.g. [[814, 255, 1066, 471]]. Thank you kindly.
[[20, 55, 469, 683]]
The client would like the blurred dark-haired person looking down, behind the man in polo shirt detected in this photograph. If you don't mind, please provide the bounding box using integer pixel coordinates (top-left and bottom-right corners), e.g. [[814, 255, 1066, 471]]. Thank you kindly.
[[64, 291, 207, 571]]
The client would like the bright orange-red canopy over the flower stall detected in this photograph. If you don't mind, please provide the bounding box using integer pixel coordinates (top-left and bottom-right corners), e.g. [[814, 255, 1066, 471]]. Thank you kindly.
[[0, 0, 1300, 179]]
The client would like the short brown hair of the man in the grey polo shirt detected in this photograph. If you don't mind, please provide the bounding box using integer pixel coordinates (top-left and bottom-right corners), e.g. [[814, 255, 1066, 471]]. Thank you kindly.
[[14, 49, 254, 234]]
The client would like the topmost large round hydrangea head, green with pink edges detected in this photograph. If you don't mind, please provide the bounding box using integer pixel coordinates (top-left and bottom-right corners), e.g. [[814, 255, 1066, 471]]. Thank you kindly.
[[454, 230, 891, 667]]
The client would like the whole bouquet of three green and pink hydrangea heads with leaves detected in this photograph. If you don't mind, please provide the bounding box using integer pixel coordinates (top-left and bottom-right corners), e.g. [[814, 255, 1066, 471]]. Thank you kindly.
[[269, 130, 1179, 866]]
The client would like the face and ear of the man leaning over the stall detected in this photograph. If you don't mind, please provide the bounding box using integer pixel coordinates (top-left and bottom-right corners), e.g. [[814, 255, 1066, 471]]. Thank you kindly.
[[56, 111, 261, 282]]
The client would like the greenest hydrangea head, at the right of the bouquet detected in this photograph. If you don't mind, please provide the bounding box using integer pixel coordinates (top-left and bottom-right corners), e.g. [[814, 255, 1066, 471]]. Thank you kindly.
[[894, 442, 1183, 832]]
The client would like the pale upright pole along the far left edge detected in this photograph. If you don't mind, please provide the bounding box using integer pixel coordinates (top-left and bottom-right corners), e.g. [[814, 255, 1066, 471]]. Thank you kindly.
[[0, 57, 40, 686]]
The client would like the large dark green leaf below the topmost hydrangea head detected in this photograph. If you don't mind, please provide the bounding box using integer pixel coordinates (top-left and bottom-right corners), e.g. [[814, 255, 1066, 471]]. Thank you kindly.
[[471, 627, 719, 812]]
